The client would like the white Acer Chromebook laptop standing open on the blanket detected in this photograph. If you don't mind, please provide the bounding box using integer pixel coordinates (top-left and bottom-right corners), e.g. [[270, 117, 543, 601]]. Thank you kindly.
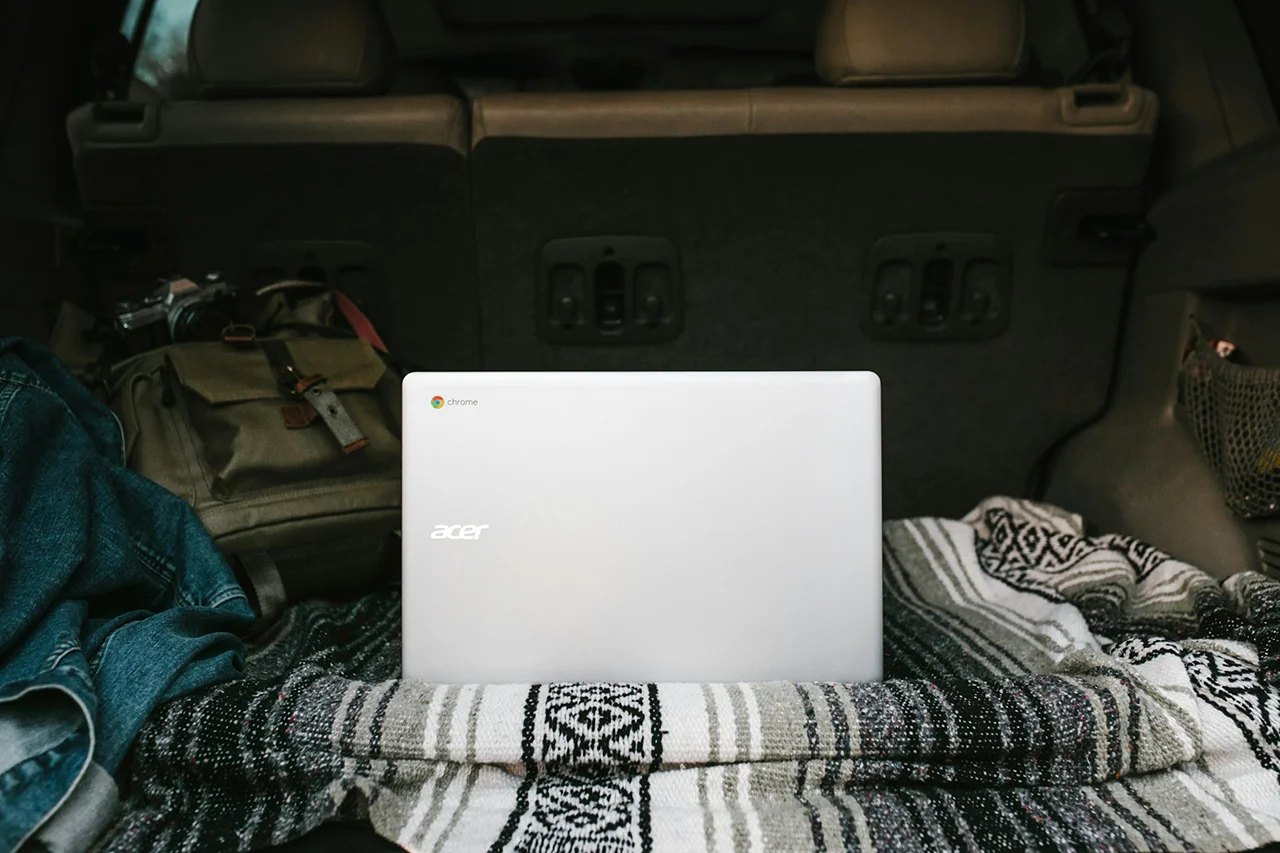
[[403, 371, 882, 684]]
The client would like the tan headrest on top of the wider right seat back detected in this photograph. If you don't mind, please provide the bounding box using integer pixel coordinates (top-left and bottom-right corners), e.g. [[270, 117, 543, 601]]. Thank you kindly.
[[815, 0, 1039, 86]]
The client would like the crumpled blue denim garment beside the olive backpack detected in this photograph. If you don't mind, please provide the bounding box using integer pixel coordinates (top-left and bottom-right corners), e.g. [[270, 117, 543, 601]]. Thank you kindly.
[[0, 338, 252, 852]]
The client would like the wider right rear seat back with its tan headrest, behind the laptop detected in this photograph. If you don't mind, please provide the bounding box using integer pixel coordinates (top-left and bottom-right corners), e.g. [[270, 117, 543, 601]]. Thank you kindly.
[[471, 0, 1156, 516]]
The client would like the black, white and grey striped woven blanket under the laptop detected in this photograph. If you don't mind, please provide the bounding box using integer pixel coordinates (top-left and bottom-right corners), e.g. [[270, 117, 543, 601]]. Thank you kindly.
[[99, 498, 1280, 853]]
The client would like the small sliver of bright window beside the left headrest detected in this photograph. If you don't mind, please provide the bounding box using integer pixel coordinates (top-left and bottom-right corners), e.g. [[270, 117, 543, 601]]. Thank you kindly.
[[120, 0, 200, 100]]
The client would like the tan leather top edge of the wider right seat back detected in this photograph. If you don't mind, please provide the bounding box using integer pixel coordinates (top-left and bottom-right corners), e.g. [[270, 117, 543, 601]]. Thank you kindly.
[[471, 86, 1157, 146]]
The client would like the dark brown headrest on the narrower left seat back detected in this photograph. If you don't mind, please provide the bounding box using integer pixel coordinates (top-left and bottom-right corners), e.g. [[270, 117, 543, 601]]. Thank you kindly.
[[188, 0, 394, 97]]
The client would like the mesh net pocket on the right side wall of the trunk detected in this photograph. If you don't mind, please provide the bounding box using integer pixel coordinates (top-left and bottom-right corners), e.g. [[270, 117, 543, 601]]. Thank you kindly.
[[1181, 337, 1280, 519]]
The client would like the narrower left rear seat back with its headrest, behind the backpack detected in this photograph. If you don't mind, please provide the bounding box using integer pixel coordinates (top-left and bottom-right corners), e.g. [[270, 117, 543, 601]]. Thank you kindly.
[[69, 0, 479, 369]]
